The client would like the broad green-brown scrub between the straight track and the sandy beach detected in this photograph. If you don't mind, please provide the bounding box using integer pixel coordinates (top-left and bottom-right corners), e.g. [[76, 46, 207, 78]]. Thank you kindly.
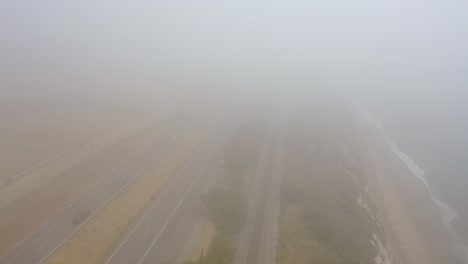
[[277, 97, 381, 264]]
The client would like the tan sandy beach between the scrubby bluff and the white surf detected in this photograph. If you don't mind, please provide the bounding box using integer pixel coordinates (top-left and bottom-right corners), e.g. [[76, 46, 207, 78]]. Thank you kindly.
[[368, 130, 461, 264]]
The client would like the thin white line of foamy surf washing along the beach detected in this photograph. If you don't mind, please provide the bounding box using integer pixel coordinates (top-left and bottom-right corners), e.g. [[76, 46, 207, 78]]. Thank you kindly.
[[353, 101, 468, 264]]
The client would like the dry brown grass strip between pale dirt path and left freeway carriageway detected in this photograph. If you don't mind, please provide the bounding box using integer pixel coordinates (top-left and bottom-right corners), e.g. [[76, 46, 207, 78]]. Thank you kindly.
[[0, 126, 162, 254]]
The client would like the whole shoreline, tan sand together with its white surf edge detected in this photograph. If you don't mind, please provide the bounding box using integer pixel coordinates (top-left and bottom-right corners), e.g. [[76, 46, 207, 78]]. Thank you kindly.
[[352, 101, 468, 264]]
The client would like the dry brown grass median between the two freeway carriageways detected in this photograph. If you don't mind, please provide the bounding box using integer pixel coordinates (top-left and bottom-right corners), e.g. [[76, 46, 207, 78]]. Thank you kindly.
[[48, 131, 204, 264]]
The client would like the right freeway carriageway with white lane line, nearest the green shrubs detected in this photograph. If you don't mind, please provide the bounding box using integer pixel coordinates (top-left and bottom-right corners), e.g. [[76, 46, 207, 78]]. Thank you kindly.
[[106, 126, 230, 264]]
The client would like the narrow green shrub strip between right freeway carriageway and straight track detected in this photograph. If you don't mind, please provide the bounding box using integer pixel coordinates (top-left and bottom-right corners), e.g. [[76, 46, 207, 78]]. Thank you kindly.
[[184, 119, 265, 264]]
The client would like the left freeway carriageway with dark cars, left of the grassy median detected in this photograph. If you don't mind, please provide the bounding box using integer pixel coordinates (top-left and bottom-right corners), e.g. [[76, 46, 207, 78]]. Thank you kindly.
[[0, 120, 192, 264]]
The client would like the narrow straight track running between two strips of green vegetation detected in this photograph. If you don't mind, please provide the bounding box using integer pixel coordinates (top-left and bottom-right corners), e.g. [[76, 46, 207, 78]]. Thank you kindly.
[[234, 102, 284, 264]]
